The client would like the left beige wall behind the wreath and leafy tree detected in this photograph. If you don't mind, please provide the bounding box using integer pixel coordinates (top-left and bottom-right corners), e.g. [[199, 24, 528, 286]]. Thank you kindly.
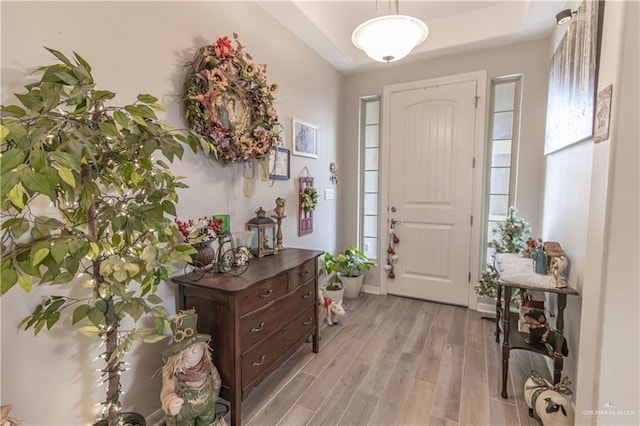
[[0, 2, 344, 425]]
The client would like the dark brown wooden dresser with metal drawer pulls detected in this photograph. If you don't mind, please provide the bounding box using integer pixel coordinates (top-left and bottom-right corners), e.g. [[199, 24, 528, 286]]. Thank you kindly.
[[172, 248, 322, 426]]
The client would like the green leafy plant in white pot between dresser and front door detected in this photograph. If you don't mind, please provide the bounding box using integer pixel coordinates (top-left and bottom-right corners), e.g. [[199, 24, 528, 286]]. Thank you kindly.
[[321, 245, 373, 300]]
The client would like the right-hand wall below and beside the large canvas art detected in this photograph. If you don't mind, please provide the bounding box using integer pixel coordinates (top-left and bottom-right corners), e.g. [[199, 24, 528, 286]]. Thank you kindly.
[[543, 1, 640, 425]]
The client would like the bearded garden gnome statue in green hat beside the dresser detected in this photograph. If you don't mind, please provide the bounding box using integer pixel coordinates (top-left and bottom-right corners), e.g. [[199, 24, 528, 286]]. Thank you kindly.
[[160, 309, 226, 426]]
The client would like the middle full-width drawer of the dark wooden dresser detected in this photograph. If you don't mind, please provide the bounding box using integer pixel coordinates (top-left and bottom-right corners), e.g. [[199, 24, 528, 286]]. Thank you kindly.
[[240, 280, 315, 352]]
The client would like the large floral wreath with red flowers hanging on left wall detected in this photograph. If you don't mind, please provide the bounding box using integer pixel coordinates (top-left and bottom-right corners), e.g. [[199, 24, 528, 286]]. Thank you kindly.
[[183, 33, 281, 162]]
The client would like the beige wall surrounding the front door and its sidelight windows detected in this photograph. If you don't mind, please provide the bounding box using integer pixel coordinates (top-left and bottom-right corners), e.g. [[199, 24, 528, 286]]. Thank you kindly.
[[338, 39, 549, 286]]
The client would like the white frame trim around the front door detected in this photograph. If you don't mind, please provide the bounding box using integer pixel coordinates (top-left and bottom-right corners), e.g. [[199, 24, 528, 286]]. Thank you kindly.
[[378, 70, 487, 310]]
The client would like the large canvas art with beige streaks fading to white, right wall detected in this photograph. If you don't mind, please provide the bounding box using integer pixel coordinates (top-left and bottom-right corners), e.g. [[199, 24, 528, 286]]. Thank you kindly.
[[544, 0, 604, 155]]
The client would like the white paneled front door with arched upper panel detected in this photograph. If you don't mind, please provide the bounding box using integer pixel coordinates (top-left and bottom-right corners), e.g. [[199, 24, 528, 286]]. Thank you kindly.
[[383, 75, 478, 306]]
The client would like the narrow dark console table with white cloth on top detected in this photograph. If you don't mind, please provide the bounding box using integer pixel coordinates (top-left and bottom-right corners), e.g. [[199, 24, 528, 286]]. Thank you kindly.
[[495, 253, 580, 398]]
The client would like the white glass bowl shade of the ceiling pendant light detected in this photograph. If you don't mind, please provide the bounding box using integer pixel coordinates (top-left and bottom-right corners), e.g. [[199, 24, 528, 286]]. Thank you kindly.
[[351, 15, 429, 62]]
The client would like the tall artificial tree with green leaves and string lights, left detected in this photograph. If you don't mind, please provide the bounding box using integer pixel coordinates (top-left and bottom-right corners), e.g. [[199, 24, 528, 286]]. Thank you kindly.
[[0, 49, 215, 426]]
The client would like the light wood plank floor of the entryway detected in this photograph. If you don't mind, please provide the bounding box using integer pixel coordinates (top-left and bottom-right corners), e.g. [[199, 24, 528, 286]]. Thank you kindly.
[[242, 295, 547, 426]]
